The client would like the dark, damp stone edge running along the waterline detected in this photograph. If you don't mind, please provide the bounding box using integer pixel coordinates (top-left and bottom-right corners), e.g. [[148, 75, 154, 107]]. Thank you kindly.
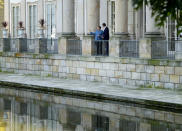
[[0, 81, 182, 113]]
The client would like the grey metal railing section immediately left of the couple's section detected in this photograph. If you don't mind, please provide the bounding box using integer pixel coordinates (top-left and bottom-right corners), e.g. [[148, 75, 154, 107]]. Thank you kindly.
[[67, 39, 82, 55]]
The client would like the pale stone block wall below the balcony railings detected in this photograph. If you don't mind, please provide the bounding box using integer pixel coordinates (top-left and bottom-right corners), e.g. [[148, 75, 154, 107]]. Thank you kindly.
[[0, 53, 182, 89]]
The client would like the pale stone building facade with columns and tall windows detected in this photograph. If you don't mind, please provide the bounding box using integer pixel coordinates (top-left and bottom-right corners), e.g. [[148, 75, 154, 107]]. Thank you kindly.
[[4, 0, 178, 39]]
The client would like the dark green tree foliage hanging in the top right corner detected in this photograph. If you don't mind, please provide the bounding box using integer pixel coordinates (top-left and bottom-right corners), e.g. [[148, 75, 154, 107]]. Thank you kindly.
[[133, 0, 182, 34]]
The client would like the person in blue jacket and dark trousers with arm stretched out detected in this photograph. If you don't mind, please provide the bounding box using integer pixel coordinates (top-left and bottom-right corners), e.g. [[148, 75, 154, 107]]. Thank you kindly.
[[90, 26, 103, 55]]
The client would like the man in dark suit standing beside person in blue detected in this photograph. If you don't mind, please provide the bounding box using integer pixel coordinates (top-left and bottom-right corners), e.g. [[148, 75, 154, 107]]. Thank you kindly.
[[102, 23, 109, 56]]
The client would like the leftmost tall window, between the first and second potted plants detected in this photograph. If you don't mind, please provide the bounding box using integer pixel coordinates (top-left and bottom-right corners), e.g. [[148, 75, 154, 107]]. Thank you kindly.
[[12, 6, 20, 37]]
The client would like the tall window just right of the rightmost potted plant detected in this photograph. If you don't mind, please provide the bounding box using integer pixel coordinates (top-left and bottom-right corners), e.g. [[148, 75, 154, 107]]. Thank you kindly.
[[46, 2, 56, 38]]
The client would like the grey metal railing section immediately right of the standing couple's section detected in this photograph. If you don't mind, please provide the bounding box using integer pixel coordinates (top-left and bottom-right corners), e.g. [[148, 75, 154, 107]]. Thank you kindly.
[[119, 40, 139, 58]]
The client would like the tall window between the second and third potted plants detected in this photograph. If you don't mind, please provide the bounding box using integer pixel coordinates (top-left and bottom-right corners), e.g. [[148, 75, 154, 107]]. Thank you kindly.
[[29, 5, 37, 38]]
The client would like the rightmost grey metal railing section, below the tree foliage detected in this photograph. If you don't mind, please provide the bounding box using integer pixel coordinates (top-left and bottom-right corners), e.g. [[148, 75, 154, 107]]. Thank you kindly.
[[151, 40, 176, 59]]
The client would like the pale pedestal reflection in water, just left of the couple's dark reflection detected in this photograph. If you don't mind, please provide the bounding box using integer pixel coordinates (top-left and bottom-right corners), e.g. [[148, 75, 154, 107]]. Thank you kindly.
[[81, 113, 92, 131]]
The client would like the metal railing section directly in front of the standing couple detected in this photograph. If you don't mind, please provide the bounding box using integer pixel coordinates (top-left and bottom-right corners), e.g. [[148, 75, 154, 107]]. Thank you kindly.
[[92, 40, 109, 56]]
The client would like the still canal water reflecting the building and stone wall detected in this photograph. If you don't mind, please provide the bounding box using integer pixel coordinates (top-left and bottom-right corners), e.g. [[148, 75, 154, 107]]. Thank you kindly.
[[0, 87, 182, 131]]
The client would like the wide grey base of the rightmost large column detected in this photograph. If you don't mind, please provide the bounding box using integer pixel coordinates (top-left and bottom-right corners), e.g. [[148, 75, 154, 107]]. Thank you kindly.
[[145, 32, 165, 40]]
